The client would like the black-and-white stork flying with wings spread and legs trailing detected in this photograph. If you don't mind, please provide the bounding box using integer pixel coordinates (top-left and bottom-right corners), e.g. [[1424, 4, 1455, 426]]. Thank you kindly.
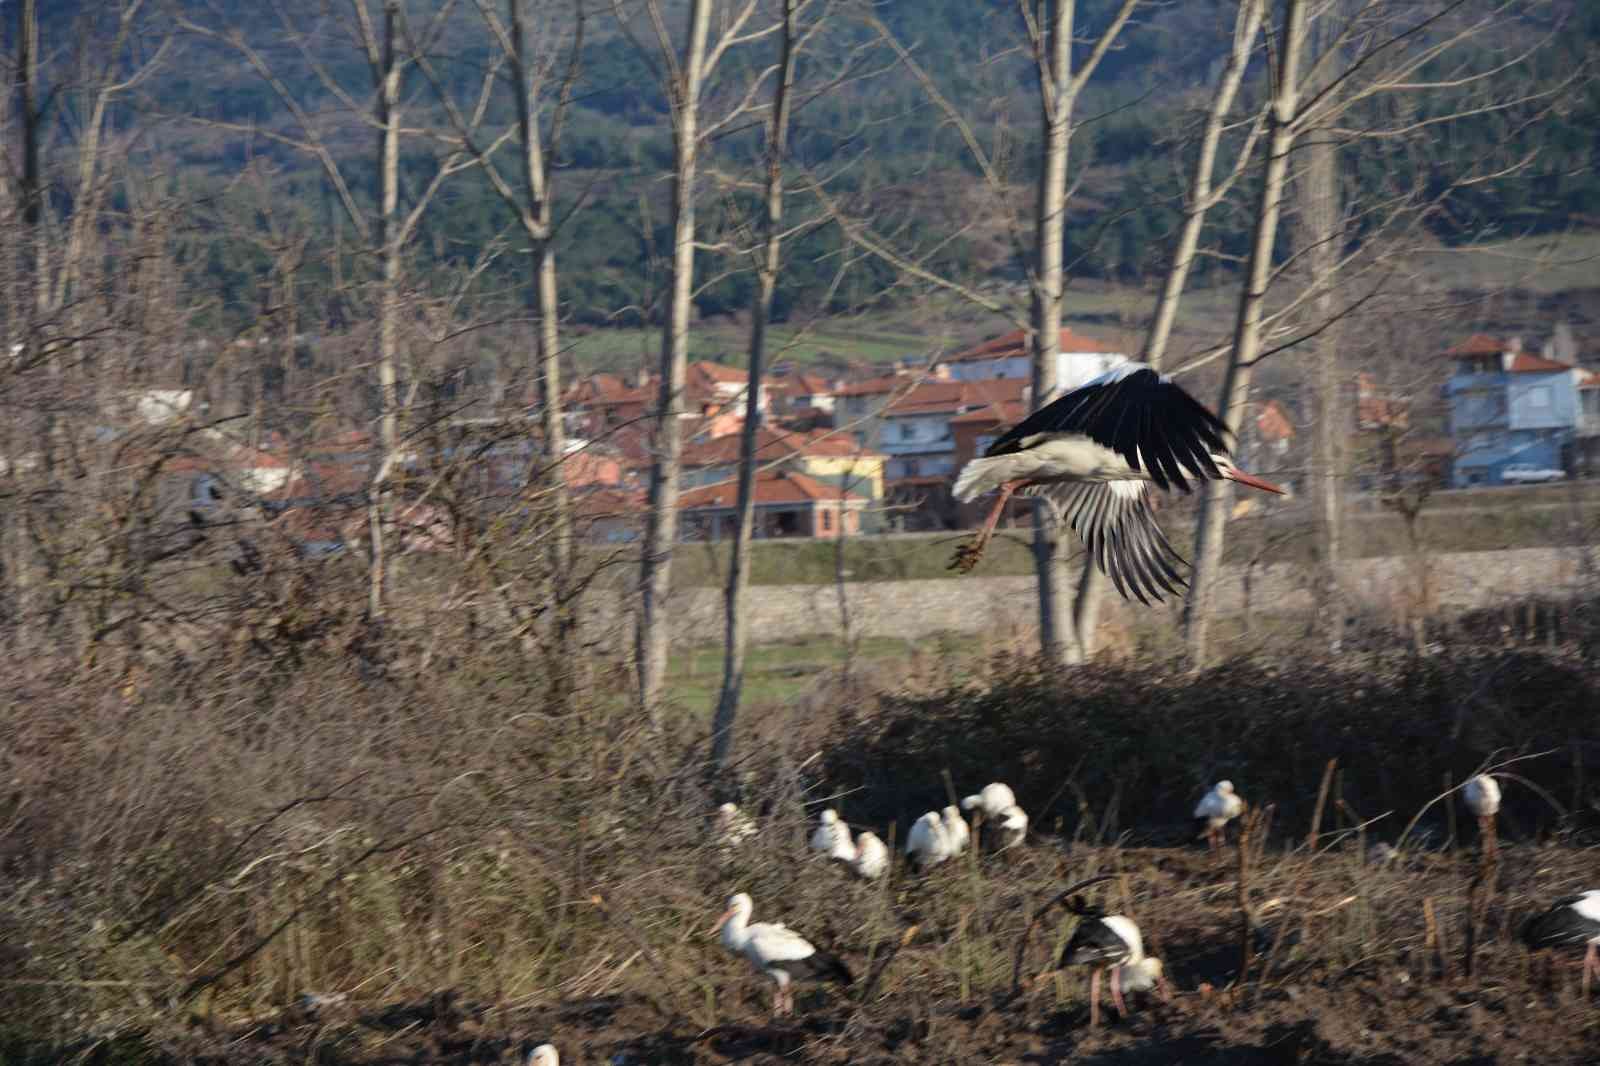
[[950, 363, 1283, 603]]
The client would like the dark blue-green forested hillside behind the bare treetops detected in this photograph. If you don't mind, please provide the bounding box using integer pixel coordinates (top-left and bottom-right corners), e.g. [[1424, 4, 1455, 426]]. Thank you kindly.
[[8, 0, 1600, 325]]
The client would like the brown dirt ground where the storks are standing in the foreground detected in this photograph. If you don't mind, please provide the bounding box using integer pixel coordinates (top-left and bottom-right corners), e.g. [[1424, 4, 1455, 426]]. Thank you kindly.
[[81, 844, 1600, 1066]]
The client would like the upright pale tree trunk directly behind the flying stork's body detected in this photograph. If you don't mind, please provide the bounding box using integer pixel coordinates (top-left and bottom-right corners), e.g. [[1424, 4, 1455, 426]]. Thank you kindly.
[[1030, 0, 1083, 663]]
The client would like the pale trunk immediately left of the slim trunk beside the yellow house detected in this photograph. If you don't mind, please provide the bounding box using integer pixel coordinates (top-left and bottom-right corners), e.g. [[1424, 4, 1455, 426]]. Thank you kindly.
[[637, 0, 712, 713]]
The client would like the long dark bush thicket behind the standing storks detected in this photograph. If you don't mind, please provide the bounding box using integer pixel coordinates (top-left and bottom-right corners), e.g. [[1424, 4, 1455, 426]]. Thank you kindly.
[[827, 650, 1600, 840]]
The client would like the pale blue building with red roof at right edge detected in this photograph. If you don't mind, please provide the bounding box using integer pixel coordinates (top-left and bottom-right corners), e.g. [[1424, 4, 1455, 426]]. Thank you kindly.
[[1445, 333, 1600, 488]]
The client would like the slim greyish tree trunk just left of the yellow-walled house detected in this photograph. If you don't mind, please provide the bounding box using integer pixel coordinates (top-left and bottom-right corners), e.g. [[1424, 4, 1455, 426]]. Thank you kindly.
[[710, 0, 796, 771]]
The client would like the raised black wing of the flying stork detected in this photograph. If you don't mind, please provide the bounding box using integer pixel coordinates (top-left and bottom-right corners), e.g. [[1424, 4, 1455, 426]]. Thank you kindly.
[[984, 368, 1230, 491]]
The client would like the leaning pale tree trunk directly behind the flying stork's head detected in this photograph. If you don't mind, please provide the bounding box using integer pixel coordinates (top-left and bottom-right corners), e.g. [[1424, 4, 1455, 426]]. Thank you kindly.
[[1184, 0, 1307, 666]]
